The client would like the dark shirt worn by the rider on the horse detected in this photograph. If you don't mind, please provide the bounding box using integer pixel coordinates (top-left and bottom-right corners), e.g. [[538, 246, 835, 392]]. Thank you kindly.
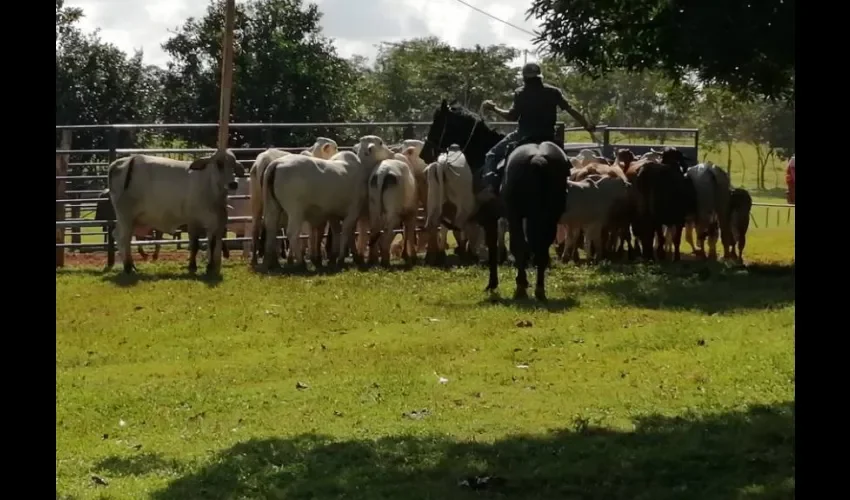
[[508, 80, 570, 137]]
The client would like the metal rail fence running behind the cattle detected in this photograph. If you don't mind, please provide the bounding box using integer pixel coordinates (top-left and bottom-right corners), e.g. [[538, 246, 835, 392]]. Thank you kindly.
[[55, 122, 793, 266]]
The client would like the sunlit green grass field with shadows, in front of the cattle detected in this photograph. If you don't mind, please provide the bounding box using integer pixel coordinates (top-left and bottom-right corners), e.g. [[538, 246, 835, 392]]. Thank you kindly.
[[56, 225, 795, 500]]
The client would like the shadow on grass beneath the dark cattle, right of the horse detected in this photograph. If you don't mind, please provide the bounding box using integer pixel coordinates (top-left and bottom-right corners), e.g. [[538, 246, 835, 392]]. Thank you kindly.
[[562, 262, 795, 314]]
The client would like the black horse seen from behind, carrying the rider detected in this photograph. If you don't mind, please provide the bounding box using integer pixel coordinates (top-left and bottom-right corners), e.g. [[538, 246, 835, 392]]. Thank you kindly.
[[420, 99, 570, 300]]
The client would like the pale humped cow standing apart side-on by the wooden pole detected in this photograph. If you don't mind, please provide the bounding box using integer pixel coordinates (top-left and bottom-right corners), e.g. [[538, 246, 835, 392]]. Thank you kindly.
[[107, 150, 244, 274]]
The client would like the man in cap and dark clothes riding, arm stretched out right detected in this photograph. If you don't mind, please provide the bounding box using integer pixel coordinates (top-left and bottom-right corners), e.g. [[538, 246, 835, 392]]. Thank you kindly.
[[481, 63, 596, 196]]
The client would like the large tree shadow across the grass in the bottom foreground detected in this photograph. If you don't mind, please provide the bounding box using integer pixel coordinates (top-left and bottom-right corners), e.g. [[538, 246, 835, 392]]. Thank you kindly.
[[150, 402, 795, 500]]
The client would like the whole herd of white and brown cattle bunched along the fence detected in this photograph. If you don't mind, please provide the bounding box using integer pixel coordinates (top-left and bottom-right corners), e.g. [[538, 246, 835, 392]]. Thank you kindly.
[[99, 102, 752, 298]]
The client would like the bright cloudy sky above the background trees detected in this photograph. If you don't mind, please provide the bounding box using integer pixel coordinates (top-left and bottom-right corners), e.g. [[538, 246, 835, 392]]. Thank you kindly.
[[65, 0, 537, 66]]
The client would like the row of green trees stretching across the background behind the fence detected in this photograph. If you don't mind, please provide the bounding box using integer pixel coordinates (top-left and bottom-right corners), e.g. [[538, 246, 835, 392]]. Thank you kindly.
[[56, 0, 795, 188]]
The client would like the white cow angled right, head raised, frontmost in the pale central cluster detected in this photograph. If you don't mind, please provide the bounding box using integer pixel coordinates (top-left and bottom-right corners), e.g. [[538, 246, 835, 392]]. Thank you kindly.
[[263, 135, 393, 268]]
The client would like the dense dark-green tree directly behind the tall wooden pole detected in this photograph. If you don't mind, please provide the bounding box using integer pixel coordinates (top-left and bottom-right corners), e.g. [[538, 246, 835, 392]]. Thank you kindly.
[[163, 0, 357, 146]]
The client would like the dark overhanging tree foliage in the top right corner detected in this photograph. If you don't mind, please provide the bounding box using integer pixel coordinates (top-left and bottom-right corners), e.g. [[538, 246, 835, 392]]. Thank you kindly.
[[528, 0, 796, 98]]
